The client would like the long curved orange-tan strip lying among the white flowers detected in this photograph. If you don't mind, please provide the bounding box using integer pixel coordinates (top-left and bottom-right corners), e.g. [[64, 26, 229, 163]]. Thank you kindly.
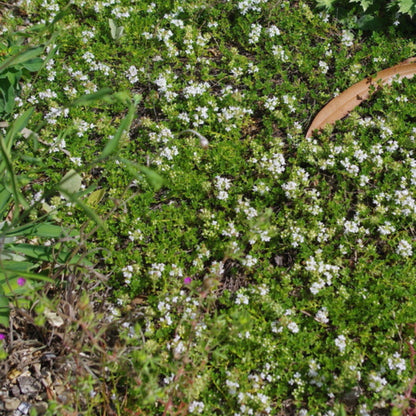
[[306, 57, 416, 138]]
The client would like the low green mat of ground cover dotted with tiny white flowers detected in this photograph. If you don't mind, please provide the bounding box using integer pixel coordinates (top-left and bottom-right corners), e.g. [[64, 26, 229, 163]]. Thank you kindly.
[[1, 0, 416, 416]]
